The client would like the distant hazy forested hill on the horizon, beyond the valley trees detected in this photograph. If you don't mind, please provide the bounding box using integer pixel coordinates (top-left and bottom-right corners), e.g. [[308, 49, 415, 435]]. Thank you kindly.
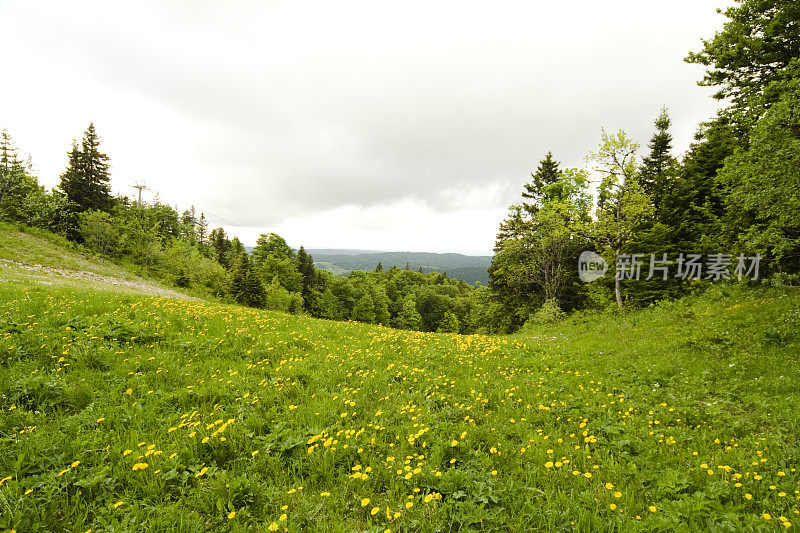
[[308, 249, 492, 285]]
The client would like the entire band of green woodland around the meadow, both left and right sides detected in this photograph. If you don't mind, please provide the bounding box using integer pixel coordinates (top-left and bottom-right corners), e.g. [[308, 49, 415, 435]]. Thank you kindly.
[[0, 0, 800, 333]]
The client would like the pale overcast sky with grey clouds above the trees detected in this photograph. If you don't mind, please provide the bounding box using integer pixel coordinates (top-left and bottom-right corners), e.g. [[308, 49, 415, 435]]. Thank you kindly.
[[0, 0, 730, 254]]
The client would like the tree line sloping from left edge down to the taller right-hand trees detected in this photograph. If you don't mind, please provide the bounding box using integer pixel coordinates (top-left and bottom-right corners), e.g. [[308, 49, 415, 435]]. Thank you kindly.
[[0, 124, 486, 333]]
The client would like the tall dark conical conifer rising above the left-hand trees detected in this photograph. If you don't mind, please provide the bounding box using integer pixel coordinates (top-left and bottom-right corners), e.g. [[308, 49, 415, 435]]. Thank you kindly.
[[59, 124, 114, 212]]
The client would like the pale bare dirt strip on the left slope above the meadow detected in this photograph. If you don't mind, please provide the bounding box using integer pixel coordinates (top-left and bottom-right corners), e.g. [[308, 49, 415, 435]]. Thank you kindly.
[[0, 259, 198, 300]]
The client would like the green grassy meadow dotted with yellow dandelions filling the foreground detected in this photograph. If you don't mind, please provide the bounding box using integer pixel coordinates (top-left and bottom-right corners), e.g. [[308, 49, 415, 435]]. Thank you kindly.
[[0, 276, 800, 532]]
